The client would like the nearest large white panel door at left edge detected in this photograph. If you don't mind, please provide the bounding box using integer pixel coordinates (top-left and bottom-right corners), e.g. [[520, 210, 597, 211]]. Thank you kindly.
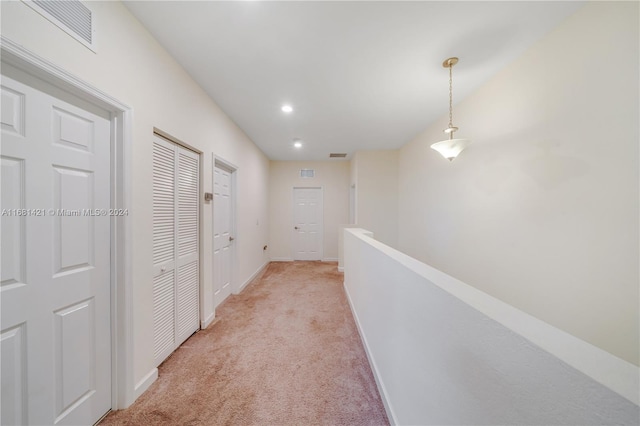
[[0, 68, 111, 425]]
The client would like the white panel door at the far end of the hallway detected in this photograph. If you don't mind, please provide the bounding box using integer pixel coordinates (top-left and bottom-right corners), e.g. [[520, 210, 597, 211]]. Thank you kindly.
[[293, 188, 323, 260]]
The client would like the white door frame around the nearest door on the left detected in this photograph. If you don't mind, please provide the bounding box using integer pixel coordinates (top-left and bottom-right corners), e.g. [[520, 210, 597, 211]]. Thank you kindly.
[[0, 36, 135, 410]]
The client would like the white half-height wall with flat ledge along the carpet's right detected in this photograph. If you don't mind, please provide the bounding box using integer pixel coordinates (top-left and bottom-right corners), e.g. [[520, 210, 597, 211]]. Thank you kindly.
[[344, 229, 640, 425]]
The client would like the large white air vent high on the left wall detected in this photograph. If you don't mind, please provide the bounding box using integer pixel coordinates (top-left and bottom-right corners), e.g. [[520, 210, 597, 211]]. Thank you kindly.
[[23, 0, 95, 50]]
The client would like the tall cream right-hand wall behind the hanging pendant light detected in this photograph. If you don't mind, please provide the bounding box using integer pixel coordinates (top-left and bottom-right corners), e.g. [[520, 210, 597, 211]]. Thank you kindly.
[[398, 2, 640, 365]]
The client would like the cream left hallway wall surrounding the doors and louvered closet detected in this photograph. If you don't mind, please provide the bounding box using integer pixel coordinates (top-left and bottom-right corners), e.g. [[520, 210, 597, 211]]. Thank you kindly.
[[1, 1, 269, 392]]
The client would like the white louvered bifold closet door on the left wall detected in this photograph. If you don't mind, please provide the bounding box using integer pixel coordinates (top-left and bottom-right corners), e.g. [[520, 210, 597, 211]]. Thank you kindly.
[[153, 136, 199, 364]]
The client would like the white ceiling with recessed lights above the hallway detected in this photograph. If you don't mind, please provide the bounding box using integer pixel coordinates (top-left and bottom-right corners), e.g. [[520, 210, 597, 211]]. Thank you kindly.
[[125, 1, 583, 161]]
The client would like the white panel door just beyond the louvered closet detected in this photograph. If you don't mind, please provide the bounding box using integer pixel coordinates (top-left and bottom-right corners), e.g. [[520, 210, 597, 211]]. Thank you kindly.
[[213, 166, 233, 307]]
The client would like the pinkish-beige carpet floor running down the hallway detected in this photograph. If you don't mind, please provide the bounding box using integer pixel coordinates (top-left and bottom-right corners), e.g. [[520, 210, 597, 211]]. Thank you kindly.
[[101, 262, 389, 426]]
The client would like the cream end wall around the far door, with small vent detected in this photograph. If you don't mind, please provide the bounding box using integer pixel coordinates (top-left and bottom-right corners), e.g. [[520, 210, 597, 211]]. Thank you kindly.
[[269, 160, 350, 261]]
